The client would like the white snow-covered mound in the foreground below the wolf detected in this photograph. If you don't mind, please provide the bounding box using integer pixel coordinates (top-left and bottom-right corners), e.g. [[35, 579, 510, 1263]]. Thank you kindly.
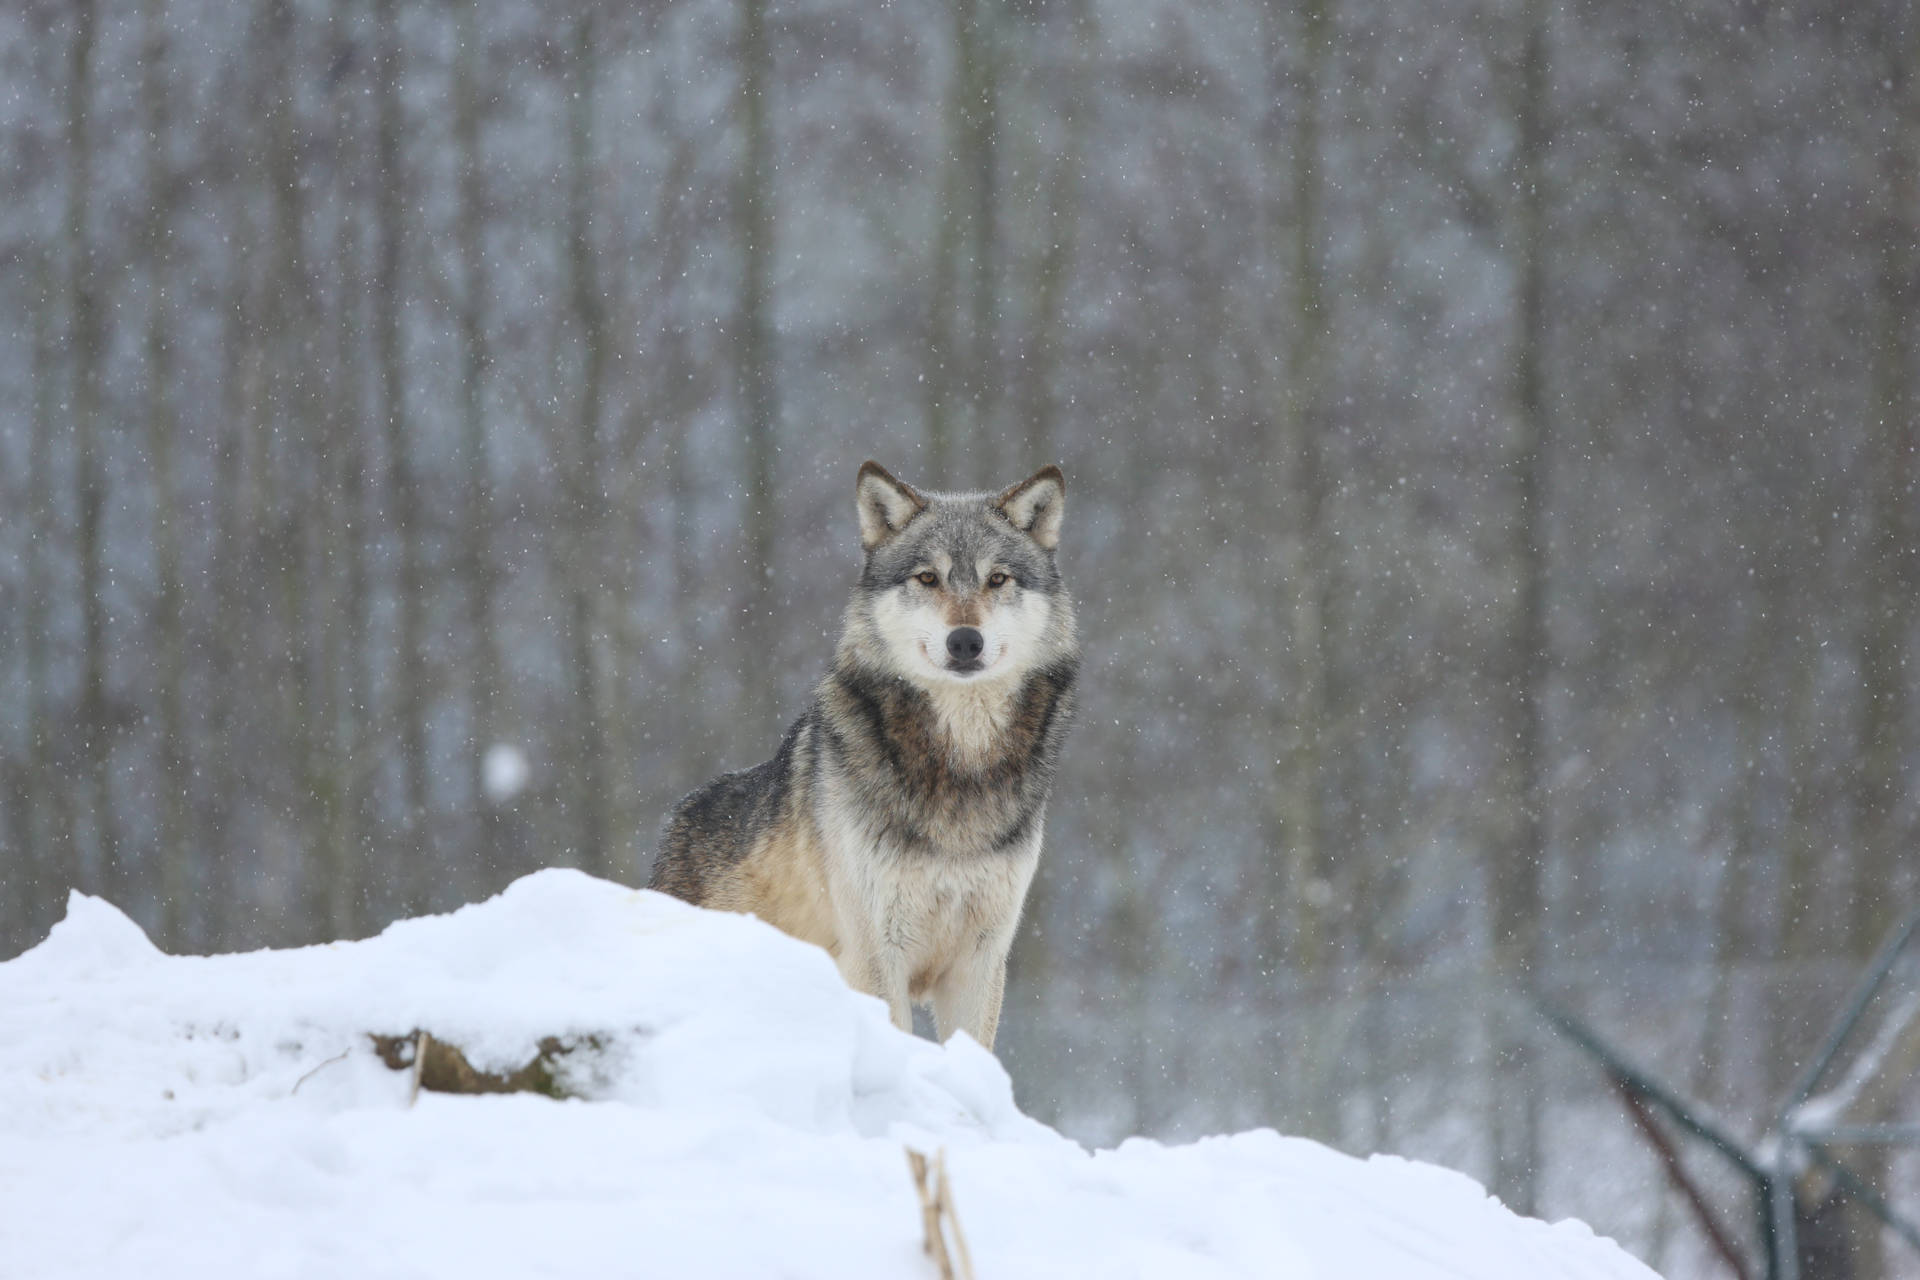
[[0, 871, 1653, 1280]]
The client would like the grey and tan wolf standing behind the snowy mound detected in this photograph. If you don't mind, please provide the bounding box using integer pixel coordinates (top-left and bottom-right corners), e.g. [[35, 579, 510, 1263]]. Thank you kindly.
[[649, 461, 1079, 1050]]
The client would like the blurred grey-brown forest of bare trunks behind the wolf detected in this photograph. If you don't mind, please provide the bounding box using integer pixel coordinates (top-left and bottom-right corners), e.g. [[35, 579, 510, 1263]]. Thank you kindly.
[[0, 0, 1920, 1276]]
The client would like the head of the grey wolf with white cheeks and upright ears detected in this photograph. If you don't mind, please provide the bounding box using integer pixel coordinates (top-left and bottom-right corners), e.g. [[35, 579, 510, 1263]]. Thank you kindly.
[[843, 454, 1075, 685]]
